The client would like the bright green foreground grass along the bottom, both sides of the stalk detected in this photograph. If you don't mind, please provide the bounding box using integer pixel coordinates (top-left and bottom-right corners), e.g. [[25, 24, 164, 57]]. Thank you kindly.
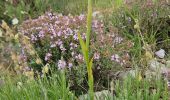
[[0, 71, 169, 100]]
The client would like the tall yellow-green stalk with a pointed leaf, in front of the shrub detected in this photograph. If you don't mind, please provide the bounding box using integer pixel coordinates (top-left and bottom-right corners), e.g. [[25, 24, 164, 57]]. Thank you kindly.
[[78, 0, 94, 100]]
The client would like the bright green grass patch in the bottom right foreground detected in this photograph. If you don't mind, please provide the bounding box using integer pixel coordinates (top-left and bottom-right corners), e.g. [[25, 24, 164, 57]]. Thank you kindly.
[[114, 76, 169, 100]]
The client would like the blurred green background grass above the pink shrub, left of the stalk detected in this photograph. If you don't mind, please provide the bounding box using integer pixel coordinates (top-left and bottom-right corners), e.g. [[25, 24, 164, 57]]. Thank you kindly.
[[0, 0, 87, 21]]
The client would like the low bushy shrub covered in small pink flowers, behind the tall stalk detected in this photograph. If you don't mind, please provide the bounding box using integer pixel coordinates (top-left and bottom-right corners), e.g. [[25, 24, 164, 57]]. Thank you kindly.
[[19, 12, 132, 91]]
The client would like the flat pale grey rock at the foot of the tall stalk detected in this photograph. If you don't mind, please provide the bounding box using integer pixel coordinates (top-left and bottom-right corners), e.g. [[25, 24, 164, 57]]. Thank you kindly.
[[79, 90, 112, 100]]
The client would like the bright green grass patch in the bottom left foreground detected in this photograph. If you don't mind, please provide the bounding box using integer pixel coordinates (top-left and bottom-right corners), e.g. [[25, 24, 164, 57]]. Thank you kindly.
[[0, 72, 75, 100]]
